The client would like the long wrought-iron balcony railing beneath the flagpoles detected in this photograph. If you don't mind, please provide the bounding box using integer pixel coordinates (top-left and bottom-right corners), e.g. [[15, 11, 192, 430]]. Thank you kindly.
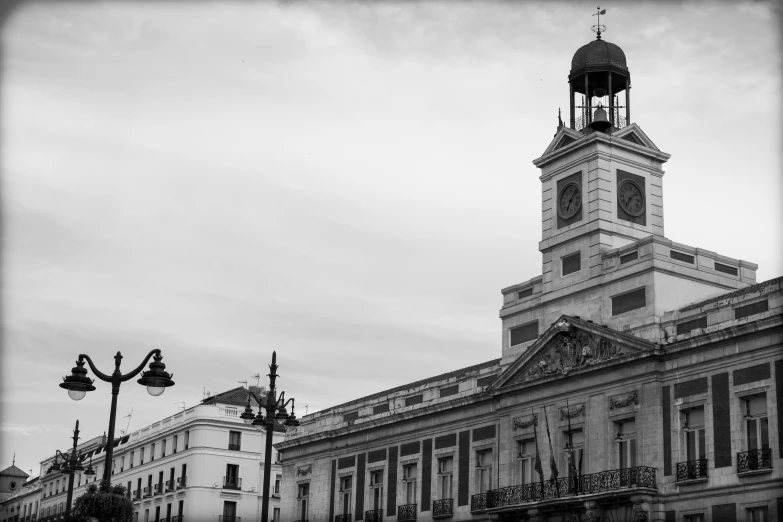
[[484, 466, 657, 511]]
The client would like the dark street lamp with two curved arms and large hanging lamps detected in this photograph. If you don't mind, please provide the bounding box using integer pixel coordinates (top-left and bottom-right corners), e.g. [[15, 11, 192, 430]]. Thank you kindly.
[[60, 349, 174, 483]]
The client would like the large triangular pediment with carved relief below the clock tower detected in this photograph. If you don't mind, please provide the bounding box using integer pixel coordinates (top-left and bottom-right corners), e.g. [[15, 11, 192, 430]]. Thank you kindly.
[[488, 315, 657, 391]]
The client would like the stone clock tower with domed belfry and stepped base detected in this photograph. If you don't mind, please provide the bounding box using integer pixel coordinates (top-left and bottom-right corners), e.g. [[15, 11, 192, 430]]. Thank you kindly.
[[500, 25, 757, 364]]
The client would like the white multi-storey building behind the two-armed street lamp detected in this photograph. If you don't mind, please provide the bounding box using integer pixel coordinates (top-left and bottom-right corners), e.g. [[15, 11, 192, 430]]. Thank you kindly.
[[33, 387, 284, 522]]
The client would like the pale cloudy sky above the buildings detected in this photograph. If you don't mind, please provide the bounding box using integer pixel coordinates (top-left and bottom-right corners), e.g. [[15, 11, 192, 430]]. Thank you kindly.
[[0, 1, 783, 476]]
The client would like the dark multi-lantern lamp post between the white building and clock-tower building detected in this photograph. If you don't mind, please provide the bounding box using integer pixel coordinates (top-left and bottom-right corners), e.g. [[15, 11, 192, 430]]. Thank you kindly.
[[240, 352, 299, 522]]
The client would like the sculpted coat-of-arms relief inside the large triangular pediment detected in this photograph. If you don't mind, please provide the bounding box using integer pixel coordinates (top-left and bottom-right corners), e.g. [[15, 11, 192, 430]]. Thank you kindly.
[[516, 321, 625, 382]]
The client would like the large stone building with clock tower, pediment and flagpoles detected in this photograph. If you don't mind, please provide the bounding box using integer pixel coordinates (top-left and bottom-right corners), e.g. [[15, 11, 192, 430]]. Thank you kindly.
[[277, 28, 783, 522]]
